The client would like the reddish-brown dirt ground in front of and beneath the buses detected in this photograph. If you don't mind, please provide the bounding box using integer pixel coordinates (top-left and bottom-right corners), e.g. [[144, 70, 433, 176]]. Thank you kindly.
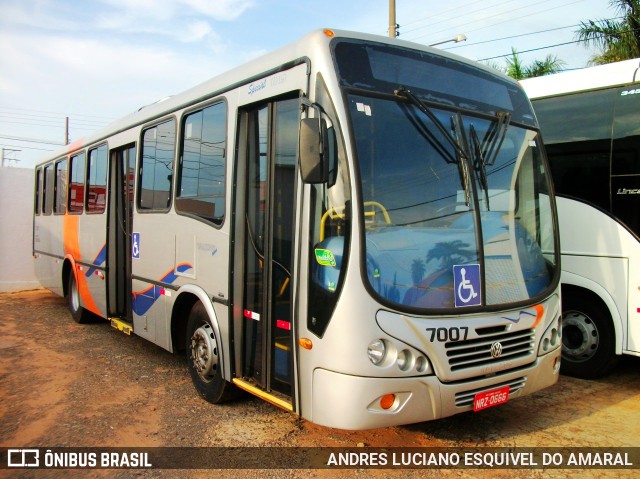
[[0, 290, 640, 478]]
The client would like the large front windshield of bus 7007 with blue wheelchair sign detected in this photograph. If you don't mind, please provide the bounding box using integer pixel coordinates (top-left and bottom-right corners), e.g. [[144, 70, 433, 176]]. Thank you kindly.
[[337, 40, 557, 313]]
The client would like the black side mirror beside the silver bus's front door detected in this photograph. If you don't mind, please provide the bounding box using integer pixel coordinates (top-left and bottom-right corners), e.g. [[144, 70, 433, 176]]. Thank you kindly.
[[300, 118, 329, 184]]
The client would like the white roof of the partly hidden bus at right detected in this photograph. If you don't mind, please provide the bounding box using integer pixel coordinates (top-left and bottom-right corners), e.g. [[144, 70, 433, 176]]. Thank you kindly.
[[520, 58, 640, 99]]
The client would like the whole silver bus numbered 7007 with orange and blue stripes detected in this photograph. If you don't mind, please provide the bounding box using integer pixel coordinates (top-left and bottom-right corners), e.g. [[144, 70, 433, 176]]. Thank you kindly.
[[34, 30, 561, 429]]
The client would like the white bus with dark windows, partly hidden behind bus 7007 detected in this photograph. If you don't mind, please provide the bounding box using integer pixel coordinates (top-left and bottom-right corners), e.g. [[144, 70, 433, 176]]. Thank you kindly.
[[522, 59, 640, 378]]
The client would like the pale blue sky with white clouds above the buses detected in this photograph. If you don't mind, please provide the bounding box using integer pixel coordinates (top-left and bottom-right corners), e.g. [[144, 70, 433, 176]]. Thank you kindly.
[[0, 0, 617, 168]]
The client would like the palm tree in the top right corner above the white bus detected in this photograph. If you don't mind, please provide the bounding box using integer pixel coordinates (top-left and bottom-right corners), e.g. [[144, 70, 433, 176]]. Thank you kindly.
[[576, 0, 640, 65]]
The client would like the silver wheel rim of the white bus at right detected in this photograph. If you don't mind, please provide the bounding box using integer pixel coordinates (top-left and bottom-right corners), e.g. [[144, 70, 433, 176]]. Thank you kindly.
[[562, 311, 600, 362]]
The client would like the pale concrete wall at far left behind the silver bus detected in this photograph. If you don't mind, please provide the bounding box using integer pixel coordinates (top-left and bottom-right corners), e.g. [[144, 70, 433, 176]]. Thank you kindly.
[[0, 168, 40, 293]]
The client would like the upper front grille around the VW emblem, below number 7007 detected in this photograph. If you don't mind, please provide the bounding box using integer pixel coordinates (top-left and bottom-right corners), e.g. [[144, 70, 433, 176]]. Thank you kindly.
[[445, 329, 535, 371]]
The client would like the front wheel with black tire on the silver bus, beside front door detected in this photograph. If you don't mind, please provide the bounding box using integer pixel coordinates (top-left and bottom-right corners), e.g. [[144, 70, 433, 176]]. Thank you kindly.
[[186, 302, 235, 404]]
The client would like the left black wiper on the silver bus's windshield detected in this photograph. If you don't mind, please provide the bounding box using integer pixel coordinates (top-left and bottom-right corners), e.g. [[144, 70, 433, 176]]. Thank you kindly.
[[393, 87, 471, 207]]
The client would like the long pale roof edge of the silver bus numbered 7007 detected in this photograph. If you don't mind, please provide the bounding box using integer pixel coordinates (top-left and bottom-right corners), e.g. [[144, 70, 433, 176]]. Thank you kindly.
[[38, 29, 508, 165]]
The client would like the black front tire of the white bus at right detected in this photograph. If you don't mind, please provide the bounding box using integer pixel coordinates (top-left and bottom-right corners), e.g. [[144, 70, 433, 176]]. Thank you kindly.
[[561, 292, 618, 379]]
